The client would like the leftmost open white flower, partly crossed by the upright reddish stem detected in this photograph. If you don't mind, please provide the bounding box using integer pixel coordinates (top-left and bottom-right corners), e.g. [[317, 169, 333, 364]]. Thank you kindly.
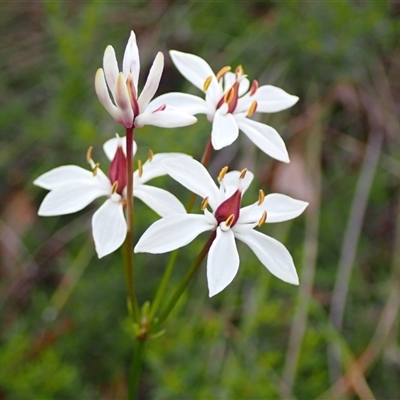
[[34, 138, 188, 258]]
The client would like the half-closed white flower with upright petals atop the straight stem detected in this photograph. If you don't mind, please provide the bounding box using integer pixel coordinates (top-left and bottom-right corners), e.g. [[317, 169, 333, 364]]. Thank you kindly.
[[95, 31, 197, 128]]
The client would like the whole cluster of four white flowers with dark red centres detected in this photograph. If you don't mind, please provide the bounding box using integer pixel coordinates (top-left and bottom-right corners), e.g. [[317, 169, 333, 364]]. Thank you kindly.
[[34, 32, 308, 296]]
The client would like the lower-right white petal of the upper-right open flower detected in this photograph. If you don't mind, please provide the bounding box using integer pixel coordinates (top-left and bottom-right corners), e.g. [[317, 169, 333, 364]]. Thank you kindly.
[[235, 115, 290, 163]]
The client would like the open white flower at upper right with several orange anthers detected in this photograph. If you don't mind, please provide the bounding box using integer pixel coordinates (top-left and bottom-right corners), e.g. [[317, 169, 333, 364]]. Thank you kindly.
[[150, 50, 298, 162]]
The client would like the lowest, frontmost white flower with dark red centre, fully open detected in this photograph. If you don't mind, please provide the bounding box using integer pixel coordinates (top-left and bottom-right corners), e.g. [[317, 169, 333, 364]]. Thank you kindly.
[[134, 158, 308, 297]]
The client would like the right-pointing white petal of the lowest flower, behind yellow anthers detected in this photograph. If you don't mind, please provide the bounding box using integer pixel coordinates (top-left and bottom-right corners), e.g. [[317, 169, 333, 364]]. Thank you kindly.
[[239, 193, 308, 223]]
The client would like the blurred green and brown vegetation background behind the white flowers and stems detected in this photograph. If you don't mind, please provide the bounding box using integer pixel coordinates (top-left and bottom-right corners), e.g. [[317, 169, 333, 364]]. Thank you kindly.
[[0, 0, 400, 399]]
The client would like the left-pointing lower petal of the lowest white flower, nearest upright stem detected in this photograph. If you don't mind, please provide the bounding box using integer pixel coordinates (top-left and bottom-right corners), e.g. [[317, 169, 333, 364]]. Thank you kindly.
[[134, 214, 215, 254]]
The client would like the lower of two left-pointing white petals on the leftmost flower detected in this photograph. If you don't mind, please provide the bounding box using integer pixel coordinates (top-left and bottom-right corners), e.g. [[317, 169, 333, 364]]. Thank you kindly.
[[38, 181, 110, 217]]
